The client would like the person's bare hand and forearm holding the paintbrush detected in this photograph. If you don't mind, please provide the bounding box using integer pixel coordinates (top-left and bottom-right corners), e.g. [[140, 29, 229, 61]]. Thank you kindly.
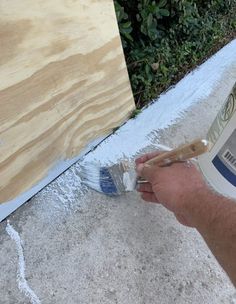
[[136, 153, 236, 286]]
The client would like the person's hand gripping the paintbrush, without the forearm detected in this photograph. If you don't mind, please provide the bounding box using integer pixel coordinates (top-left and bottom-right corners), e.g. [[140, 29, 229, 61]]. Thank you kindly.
[[136, 152, 210, 227]]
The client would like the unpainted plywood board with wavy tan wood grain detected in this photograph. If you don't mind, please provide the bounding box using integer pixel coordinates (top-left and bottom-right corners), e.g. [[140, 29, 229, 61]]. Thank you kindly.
[[0, 0, 134, 203]]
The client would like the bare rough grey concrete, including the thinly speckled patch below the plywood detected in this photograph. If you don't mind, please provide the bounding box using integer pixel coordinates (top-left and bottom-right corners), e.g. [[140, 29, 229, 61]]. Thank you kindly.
[[0, 47, 236, 304]]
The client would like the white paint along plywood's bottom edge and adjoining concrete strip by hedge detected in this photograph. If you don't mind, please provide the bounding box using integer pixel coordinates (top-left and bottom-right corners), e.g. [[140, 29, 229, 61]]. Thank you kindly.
[[0, 39, 236, 221]]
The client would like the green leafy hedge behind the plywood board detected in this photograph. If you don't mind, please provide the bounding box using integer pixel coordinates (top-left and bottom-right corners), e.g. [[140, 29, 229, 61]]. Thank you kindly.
[[115, 0, 236, 107]]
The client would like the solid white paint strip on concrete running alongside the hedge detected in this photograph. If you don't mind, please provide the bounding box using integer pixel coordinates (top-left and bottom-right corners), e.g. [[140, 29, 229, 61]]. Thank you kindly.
[[85, 39, 236, 165]]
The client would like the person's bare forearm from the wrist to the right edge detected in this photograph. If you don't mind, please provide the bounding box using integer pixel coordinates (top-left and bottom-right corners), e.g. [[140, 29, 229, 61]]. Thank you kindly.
[[192, 191, 236, 286]]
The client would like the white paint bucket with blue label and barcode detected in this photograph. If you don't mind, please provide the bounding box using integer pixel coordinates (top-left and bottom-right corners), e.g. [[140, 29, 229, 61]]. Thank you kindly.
[[199, 84, 236, 198]]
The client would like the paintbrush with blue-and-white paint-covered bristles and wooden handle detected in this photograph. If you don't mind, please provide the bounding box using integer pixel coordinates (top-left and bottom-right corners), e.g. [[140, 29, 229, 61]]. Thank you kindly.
[[80, 139, 209, 195]]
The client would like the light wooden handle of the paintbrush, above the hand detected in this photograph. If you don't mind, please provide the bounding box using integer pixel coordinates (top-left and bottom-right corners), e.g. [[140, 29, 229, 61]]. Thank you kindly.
[[146, 139, 209, 166]]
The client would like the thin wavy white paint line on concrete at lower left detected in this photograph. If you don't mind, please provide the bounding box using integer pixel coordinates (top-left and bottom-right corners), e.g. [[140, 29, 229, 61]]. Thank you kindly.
[[6, 222, 41, 304]]
